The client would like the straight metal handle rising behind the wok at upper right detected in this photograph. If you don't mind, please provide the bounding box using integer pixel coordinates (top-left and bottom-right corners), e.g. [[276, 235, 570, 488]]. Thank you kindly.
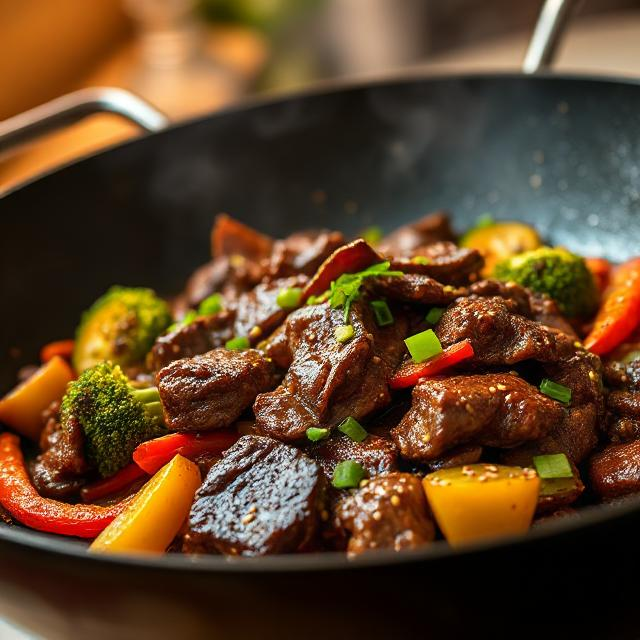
[[522, 0, 581, 74]]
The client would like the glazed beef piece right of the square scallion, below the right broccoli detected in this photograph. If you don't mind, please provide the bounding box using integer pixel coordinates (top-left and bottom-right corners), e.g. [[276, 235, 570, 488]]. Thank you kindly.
[[435, 296, 576, 366]]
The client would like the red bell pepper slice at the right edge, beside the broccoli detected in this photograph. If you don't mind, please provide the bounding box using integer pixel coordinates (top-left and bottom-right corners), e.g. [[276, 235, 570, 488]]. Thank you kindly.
[[584, 258, 640, 355]]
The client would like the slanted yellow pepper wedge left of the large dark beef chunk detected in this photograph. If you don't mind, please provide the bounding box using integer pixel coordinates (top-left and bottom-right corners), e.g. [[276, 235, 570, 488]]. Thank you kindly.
[[89, 455, 201, 553]]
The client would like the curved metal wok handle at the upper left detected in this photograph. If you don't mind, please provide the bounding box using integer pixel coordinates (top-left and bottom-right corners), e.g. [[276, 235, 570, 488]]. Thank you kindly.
[[0, 87, 169, 153]]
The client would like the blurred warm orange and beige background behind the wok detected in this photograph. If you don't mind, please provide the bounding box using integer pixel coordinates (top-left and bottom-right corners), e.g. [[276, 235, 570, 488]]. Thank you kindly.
[[0, 0, 640, 190]]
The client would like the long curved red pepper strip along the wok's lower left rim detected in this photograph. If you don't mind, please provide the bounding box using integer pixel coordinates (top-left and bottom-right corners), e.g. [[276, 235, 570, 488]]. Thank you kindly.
[[0, 433, 129, 538]]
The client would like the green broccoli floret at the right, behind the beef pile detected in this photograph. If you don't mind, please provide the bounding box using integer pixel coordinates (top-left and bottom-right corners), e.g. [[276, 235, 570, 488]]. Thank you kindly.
[[494, 247, 598, 318]]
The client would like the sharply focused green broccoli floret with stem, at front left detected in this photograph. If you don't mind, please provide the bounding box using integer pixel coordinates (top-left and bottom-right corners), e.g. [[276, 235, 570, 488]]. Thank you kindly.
[[61, 362, 166, 477]]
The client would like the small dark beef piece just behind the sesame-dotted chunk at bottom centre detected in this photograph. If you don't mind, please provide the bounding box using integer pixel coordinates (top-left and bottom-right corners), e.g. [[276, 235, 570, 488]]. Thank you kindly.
[[306, 435, 398, 481]]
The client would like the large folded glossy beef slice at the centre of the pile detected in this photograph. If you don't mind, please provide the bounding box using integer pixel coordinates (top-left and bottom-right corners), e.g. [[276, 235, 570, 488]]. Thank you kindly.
[[253, 300, 405, 441]]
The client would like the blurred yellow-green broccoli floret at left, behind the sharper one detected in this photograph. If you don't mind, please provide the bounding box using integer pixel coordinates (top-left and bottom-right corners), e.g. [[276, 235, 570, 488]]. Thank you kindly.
[[73, 287, 172, 372]]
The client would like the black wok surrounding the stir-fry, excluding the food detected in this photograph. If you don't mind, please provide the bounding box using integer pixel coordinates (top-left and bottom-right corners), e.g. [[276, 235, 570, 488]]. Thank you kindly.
[[0, 3, 640, 639]]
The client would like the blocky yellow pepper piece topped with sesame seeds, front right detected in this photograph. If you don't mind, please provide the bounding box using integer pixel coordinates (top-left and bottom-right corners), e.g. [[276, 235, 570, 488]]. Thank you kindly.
[[422, 464, 540, 546]]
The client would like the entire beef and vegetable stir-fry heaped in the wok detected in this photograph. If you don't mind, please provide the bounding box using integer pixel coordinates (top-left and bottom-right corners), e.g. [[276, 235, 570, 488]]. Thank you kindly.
[[0, 213, 640, 556]]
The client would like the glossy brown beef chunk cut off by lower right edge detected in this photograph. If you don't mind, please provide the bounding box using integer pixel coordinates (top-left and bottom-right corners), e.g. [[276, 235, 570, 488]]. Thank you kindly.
[[589, 440, 640, 499]]
